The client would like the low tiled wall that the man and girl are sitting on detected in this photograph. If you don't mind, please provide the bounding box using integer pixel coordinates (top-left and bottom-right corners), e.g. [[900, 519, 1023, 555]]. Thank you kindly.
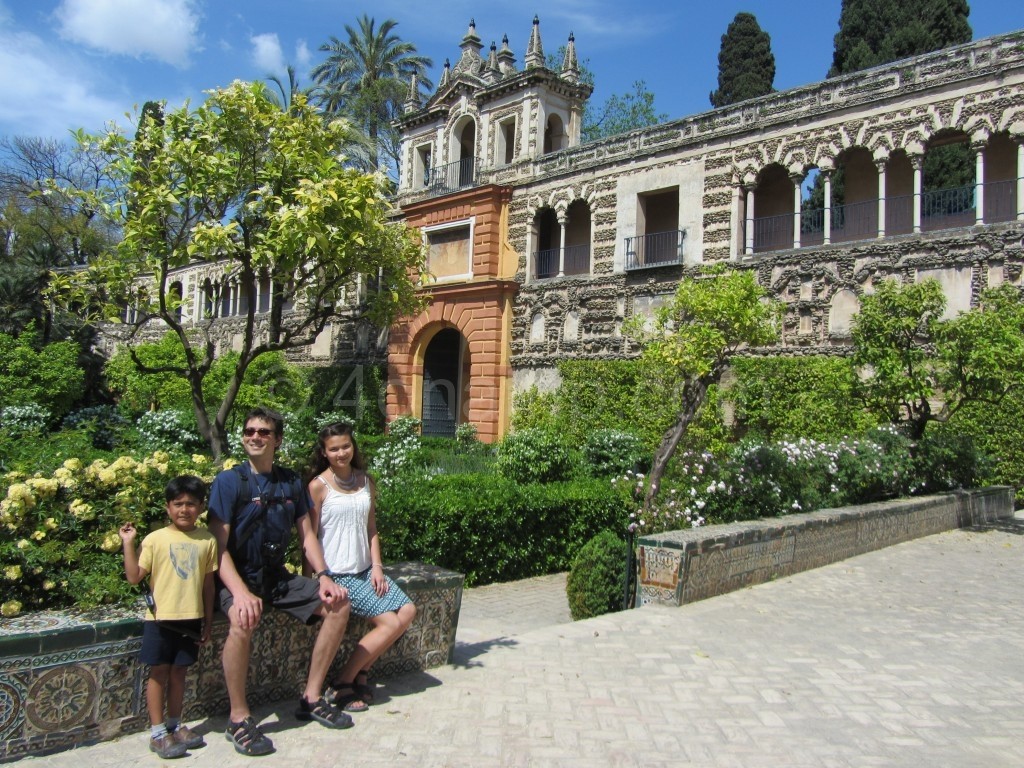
[[0, 563, 464, 761]]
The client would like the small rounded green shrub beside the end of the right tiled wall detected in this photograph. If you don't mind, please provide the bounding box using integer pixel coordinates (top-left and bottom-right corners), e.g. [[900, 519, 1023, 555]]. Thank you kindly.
[[565, 530, 629, 622]]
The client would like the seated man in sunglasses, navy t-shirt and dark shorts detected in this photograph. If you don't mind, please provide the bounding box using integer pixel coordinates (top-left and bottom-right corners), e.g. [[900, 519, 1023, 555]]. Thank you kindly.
[[208, 408, 352, 755]]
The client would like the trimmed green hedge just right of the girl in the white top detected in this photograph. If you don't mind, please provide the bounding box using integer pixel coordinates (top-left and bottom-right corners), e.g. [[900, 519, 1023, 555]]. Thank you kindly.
[[377, 474, 629, 585]]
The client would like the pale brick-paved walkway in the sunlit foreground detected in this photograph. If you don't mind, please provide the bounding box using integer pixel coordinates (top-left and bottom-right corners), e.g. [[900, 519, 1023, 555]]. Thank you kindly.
[[24, 522, 1024, 768]]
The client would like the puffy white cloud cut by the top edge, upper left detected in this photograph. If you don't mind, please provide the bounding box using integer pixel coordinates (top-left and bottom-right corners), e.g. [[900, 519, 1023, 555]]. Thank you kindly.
[[55, 0, 199, 68]]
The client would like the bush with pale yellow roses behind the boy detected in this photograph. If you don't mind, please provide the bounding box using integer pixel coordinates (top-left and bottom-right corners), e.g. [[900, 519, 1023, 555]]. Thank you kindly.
[[0, 451, 217, 617]]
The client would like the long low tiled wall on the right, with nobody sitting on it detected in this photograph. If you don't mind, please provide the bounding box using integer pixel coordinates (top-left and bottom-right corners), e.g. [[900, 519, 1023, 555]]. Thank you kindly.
[[637, 486, 1014, 605]]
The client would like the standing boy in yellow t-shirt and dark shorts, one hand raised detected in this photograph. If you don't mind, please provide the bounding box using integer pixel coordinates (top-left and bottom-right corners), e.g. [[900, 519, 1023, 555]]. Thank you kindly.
[[119, 475, 217, 758]]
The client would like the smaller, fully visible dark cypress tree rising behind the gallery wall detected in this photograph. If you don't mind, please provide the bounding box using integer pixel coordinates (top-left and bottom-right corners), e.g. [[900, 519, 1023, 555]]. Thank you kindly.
[[709, 12, 775, 106]]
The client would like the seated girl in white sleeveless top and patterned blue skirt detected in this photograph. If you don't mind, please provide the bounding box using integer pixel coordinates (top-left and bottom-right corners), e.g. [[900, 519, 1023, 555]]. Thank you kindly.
[[309, 422, 416, 712]]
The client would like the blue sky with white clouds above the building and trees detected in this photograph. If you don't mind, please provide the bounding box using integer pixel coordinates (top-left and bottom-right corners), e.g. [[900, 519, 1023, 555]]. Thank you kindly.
[[0, 0, 1024, 139]]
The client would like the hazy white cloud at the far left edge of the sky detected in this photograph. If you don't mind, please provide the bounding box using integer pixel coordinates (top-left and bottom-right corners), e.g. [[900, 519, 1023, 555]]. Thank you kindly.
[[0, 23, 125, 139]]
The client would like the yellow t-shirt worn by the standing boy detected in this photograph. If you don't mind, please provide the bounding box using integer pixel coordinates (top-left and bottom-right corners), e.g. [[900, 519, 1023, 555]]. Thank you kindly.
[[138, 525, 217, 622]]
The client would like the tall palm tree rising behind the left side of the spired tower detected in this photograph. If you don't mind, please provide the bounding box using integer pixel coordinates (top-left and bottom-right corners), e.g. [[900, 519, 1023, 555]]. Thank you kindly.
[[311, 14, 433, 170]]
